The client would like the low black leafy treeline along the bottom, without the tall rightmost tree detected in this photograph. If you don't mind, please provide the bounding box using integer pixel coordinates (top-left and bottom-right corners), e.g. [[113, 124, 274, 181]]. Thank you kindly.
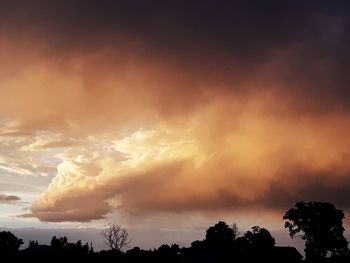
[[0, 224, 301, 263]]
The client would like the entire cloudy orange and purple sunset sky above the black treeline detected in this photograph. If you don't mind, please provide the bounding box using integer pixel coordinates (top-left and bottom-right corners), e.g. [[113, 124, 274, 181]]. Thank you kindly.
[[0, 0, 350, 252]]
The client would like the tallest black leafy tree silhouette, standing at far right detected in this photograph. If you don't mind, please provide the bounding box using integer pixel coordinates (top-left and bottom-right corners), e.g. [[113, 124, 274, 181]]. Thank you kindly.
[[283, 202, 349, 262]]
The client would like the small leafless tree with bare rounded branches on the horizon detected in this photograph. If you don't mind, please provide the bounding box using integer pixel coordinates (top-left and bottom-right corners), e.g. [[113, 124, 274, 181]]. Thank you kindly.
[[102, 223, 130, 251]]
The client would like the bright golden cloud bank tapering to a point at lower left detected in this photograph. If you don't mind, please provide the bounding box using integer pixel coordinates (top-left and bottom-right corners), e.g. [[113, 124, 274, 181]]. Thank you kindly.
[[27, 110, 350, 221]]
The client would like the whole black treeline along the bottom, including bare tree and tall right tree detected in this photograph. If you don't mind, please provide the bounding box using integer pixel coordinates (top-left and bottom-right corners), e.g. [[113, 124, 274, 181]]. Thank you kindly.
[[0, 202, 350, 263]]
